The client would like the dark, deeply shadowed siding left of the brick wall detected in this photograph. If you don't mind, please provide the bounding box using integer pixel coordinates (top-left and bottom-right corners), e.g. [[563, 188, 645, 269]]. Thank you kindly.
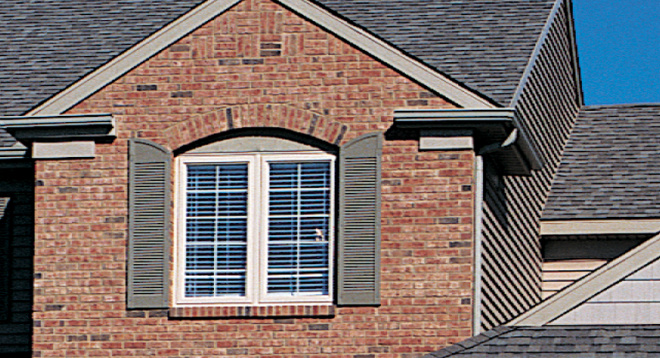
[[0, 169, 34, 356]]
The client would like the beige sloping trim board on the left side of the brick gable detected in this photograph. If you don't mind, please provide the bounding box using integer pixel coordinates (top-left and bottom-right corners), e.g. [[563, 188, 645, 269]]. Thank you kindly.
[[27, 0, 241, 116]]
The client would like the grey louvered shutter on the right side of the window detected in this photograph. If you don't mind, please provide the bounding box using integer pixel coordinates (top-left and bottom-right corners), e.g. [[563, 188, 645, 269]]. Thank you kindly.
[[337, 133, 383, 306]]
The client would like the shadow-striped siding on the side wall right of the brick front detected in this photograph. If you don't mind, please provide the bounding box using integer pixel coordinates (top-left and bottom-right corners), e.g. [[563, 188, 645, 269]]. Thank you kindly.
[[481, 2, 581, 330]]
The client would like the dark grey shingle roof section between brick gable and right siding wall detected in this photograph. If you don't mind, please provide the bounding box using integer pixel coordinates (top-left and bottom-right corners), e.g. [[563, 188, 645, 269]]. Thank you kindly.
[[317, 0, 556, 106]]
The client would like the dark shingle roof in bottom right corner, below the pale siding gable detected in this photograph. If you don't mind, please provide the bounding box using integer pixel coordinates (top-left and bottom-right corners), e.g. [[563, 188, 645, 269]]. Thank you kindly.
[[425, 325, 660, 358]]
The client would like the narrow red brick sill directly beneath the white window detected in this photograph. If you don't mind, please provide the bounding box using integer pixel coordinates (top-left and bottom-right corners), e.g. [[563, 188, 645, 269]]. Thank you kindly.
[[169, 305, 335, 318]]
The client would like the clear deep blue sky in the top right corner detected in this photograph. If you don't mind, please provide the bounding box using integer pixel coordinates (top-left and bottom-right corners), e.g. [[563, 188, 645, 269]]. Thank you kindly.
[[573, 0, 660, 105]]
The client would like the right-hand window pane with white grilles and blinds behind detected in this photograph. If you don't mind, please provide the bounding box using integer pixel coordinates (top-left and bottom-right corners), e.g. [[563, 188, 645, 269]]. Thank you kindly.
[[268, 162, 331, 296]]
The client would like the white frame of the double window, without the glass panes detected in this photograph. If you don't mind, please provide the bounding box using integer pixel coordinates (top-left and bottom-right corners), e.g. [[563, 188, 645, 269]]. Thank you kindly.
[[173, 151, 336, 306]]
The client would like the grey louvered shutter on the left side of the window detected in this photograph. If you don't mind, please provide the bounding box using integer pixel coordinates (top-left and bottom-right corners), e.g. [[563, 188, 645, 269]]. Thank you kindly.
[[127, 139, 171, 308]]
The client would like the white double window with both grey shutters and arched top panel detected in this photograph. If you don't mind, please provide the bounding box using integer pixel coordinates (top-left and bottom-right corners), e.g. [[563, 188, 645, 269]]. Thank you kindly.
[[127, 133, 382, 309]]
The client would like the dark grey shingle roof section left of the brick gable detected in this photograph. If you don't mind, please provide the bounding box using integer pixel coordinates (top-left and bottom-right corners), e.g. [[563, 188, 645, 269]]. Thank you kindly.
[[0, 0, 203, 117]]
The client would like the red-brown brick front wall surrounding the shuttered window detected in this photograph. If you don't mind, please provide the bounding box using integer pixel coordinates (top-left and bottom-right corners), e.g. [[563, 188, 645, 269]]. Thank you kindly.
[[33, 0, 474, 358]]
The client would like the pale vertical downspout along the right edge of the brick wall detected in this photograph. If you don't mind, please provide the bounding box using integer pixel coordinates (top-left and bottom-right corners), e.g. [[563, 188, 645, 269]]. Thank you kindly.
[[472, 155, 484, 336]]
